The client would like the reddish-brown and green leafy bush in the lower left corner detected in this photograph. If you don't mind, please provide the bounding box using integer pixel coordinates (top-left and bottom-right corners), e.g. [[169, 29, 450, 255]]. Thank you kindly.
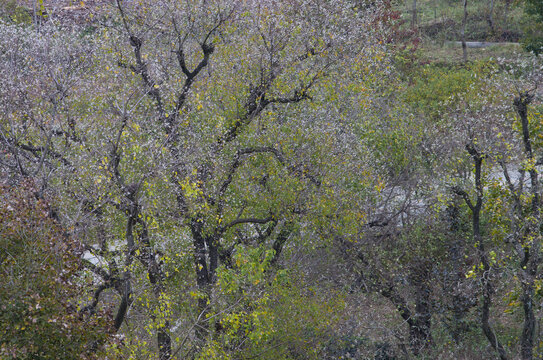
[[0, 185, 112, 359]]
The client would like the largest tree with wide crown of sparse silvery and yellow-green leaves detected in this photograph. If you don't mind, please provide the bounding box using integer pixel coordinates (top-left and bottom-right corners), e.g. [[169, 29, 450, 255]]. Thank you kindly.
[[2, 1, 392, 359]]
